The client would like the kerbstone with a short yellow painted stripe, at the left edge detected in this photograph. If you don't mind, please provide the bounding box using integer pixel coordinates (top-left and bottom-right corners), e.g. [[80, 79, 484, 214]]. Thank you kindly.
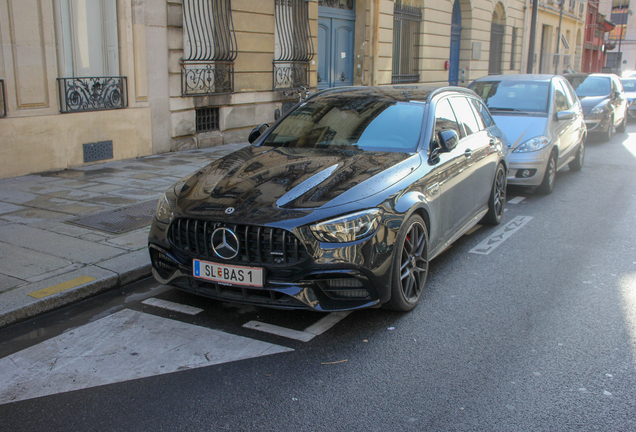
[[0, 266, 119, 328]]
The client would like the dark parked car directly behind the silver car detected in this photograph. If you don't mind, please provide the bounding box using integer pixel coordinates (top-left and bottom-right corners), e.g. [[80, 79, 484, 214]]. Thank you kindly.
[[564, 73, 627, 141]]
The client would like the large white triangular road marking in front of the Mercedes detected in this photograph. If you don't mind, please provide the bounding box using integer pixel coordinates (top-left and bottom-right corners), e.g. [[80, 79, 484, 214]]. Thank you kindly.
[[0, 309, 293, 404]]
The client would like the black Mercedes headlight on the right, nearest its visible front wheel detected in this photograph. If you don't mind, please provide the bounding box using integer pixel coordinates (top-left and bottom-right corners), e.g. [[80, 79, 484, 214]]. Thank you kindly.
[[311, 209, 382, 243]]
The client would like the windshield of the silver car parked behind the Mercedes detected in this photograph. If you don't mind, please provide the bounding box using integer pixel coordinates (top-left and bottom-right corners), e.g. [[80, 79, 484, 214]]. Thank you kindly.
[[471, 80, 550, 113]]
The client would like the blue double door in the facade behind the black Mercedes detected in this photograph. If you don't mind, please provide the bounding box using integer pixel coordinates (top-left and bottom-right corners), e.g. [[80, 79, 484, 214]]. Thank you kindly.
[[318, 6, 355, 89]]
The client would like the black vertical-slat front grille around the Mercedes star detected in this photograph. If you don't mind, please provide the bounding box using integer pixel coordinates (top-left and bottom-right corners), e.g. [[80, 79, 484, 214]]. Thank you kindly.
[[168, 218, 307, 265]]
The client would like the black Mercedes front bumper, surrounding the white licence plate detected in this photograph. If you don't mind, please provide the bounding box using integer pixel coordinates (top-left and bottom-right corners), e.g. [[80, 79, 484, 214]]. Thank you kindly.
[[149, 221, 397, 312]]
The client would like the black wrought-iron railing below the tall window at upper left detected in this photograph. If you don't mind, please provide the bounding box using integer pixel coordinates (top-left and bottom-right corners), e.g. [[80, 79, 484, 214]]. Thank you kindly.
[[57, 77, 128, 113]]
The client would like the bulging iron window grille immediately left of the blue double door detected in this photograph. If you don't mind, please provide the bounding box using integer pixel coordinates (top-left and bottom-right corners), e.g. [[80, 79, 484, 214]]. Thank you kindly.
[[273, 0, 314, 90]]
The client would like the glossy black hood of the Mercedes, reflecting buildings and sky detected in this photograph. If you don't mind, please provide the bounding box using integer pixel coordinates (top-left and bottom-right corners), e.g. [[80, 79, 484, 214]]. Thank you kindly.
[[175, 147, 421, 221]]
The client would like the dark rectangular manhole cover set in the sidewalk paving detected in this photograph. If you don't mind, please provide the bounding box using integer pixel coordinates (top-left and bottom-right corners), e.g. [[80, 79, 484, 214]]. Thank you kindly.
[[66, 200, 157, 234]]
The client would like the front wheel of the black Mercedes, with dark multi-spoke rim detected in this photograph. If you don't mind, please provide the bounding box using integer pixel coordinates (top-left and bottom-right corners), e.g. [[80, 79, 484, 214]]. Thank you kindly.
[[384, 214, 428, 312]]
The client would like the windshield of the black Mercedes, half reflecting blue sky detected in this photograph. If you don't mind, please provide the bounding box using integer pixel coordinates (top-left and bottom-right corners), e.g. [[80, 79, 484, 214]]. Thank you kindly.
[[262, 95, 424, 153]]
